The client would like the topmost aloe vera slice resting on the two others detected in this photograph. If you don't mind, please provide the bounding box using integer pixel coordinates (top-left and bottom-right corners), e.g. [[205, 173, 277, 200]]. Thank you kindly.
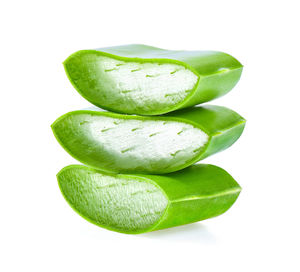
[[64, 44, 242, 115]]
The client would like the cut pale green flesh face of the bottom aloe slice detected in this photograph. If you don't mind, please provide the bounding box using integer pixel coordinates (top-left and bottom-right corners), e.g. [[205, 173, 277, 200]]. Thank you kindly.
[[60, 170, 168, 232]]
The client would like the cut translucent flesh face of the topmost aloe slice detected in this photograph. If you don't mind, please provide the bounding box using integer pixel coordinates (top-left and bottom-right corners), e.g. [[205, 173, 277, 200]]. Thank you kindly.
[[74, 54, 198, 113]]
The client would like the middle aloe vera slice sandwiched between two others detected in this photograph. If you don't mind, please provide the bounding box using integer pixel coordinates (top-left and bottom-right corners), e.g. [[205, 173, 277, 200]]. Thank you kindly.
[[52, 106, 245, 174]]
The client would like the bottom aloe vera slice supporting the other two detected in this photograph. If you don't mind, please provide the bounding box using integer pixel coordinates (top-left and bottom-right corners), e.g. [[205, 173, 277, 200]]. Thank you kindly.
[[57, 164, 241, 233]]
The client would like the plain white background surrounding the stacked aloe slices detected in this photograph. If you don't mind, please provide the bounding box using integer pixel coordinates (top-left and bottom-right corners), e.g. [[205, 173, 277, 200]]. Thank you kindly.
[[0, 0, 300, 272]]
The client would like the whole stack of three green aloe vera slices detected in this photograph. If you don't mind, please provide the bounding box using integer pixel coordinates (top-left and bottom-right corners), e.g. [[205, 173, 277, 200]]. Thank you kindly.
[[52, 45, 246, 233]]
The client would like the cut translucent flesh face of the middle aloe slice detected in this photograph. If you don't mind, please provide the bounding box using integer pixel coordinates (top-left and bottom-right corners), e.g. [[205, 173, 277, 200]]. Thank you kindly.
[[65, 114, 208, 172]]
